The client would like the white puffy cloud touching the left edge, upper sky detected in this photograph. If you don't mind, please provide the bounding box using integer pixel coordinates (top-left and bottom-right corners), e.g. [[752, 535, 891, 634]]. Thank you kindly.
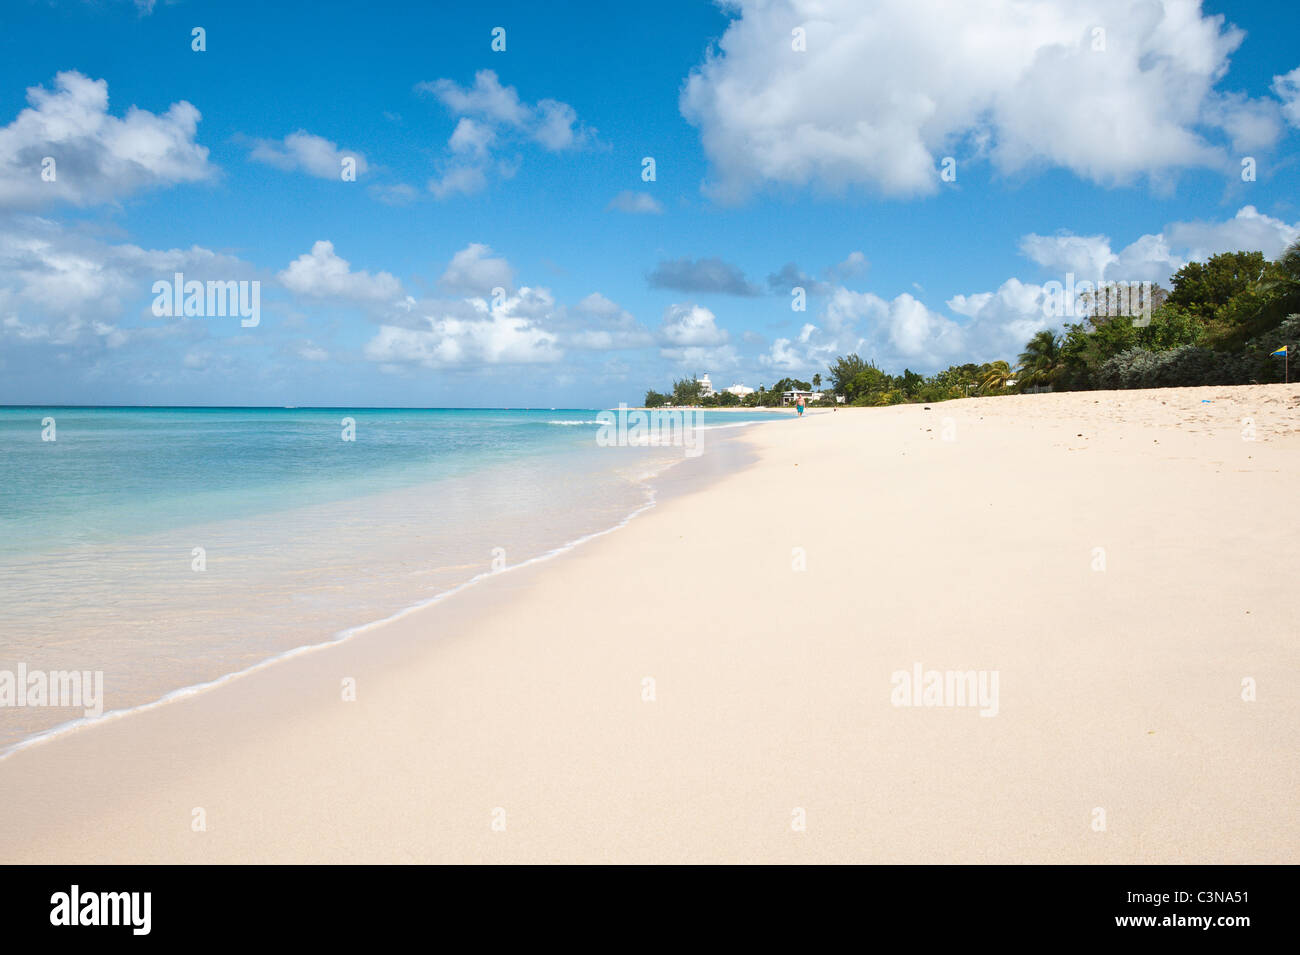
[[0, 70, 215, 209]]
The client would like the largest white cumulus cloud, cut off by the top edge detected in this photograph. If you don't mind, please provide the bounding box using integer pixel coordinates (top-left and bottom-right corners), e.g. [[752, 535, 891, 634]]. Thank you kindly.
[[680, 0, 1275, 201]]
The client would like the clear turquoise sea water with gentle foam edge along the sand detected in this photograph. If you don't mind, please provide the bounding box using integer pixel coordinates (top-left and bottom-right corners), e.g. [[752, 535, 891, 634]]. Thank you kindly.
[[0, 408, 772, 752]]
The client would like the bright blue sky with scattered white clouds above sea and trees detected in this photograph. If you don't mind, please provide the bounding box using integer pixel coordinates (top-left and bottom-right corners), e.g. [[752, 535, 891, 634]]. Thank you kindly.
[[0, 0, 1300, 407]]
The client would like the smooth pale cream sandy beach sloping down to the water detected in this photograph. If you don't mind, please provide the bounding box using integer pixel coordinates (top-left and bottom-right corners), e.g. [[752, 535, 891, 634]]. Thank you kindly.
[[0, 385, 1300, 863]]
